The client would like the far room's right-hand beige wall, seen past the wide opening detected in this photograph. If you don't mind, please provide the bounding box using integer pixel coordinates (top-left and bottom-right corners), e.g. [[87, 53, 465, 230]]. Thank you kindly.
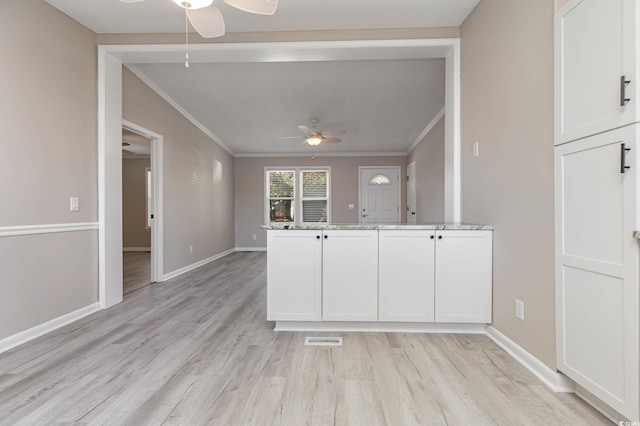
[[407, 117, 444, 222]]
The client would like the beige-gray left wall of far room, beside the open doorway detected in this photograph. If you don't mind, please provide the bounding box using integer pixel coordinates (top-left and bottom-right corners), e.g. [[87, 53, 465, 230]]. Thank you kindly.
[[122, 68, 234, 274]]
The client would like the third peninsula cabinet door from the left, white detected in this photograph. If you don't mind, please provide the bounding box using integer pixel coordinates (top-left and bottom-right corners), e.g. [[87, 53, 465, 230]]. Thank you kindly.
[[379, 230, 435, 322]]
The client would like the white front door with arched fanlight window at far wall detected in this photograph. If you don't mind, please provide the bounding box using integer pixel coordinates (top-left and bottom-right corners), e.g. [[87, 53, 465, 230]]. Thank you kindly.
[[360, 167, 400, 223]]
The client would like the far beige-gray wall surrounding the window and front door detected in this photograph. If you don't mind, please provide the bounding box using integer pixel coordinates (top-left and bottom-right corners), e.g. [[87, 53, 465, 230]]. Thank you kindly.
[[235, 157, 407, 247]]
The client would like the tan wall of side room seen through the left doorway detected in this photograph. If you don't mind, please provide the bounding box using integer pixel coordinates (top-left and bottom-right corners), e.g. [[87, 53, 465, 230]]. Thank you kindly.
[[122, 158, 151, 248]]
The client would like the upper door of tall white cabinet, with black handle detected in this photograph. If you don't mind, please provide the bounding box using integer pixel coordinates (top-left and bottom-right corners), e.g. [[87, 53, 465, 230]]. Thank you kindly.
[[555, 0, 638, 144]]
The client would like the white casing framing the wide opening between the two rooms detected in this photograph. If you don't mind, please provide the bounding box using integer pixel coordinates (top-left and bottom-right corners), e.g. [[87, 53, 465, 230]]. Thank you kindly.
[[98, 38, 460, 309]]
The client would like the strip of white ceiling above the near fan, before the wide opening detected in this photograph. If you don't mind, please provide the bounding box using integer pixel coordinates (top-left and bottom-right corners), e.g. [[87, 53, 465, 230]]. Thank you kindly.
[[46, 0, 479, 34]]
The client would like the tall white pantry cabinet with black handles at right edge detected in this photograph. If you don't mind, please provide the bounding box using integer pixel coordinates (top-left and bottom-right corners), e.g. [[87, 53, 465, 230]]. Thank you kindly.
[[555, 0, 640, 420]]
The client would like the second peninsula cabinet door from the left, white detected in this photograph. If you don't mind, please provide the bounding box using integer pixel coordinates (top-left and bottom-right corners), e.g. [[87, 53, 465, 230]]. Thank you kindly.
[[322, 230, 378, 321]]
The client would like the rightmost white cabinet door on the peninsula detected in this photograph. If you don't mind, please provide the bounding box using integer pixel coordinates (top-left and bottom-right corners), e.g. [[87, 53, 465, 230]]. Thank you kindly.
[[435, 231, 493, 323]]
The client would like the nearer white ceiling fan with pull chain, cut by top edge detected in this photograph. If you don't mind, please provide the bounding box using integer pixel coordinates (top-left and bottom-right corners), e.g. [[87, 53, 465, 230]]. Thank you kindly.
[[120, 0, 278, 64]]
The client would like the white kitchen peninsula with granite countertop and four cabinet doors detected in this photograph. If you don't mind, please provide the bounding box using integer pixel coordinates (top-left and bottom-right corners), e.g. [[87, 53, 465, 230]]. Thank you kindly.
[[263, 223, 493, 333]]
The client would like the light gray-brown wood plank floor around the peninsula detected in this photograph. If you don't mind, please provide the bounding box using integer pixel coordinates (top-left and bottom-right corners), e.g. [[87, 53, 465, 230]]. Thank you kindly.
[[0, 252, 610, 426]]
